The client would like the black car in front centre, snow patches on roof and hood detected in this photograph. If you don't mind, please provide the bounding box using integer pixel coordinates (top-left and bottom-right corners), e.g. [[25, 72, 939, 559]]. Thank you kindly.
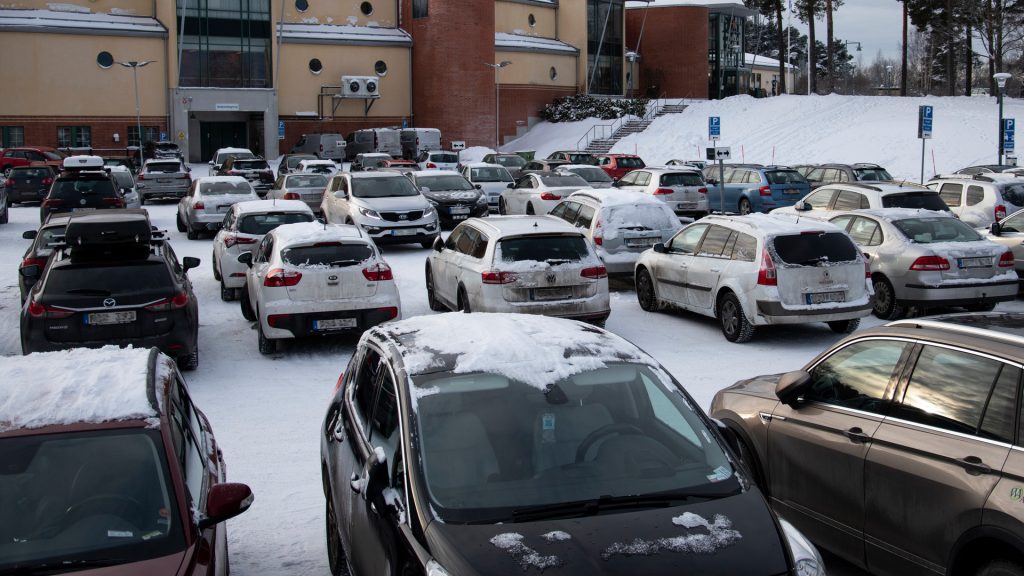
[[318, 311, 824, 576]]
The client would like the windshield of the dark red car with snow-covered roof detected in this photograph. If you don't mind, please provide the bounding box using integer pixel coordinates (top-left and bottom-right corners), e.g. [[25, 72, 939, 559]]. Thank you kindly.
[[0, 427, 184, 574]]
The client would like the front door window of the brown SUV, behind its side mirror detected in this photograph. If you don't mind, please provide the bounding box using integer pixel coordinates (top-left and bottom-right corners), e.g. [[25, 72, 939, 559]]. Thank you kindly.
[[804, 340, 909, 413]]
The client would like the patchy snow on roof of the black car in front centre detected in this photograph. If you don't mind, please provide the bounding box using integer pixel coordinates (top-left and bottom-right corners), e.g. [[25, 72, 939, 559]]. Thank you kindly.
[[372, 314, 655, 388]]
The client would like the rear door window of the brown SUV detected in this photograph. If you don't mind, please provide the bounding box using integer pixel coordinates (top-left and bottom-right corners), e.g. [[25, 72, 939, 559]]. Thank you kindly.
[[891, 345, 1002, 434]]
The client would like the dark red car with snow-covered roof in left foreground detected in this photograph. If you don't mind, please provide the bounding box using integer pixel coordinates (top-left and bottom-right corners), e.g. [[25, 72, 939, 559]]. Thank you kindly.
[[0, 346, 253, 576]]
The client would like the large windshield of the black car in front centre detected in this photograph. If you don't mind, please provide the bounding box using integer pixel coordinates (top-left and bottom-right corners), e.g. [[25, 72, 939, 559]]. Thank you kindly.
[[413, 363, 739, 524]]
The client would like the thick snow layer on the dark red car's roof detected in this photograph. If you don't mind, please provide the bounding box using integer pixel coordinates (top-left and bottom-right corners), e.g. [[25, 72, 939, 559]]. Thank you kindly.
[[0, 346, 159, 433]]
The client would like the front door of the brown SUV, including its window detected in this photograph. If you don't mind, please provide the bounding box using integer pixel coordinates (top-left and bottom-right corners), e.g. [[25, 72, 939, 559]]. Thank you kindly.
[[760, 338, 913, 567]]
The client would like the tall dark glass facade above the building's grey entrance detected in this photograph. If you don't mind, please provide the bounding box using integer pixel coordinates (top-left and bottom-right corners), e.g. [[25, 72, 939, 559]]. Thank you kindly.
[[177, 0, 273, 88]]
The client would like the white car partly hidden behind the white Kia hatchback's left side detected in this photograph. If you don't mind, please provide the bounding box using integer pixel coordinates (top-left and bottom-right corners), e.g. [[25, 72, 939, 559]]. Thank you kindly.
[[212, 200, 314, 302]]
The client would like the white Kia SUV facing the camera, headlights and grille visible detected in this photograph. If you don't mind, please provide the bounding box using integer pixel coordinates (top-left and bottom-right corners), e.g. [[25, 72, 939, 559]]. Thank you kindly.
[[321, 172, 440, 248]]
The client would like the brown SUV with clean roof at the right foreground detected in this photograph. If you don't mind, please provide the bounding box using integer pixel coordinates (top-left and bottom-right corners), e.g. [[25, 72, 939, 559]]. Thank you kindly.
[[712, 313, 1024, 576]]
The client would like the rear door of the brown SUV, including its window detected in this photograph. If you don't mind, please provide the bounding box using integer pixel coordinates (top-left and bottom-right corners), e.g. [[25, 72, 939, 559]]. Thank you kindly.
[[864, 343, 1020, 574]]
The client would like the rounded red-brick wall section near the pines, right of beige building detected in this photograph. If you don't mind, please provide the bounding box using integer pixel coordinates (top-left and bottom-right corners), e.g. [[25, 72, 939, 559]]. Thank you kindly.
[[626, 6, 708, 98]]
